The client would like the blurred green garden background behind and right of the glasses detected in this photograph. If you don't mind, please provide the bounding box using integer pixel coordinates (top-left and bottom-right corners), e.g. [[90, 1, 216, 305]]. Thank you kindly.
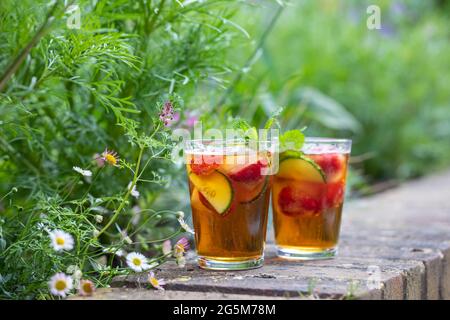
[[221, 0, 450, 191]]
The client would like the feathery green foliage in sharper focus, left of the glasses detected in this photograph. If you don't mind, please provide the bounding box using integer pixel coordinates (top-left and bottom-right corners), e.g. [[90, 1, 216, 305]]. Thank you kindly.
[[0, 0, 246, 298]]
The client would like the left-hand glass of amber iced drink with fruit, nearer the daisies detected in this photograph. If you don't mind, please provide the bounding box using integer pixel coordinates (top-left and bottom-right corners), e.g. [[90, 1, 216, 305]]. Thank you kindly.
[[185, 141, 272, 270]]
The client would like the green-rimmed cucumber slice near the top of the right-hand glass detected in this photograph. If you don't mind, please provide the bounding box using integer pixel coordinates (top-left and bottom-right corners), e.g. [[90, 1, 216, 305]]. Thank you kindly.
[[277, 155, 327, 183]]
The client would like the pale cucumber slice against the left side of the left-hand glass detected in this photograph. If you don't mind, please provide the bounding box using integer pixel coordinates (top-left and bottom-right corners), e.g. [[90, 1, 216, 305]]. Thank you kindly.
[[189, 170, 234, 214]]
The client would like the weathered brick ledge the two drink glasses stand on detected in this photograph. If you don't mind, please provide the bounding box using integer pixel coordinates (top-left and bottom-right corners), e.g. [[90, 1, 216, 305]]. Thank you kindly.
[[84, 172, 450, 299]]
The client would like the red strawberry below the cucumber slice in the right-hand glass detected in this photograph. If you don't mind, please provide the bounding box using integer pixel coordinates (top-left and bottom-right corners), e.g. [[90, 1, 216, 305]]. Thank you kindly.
[[278, 187, 322, 217]]
